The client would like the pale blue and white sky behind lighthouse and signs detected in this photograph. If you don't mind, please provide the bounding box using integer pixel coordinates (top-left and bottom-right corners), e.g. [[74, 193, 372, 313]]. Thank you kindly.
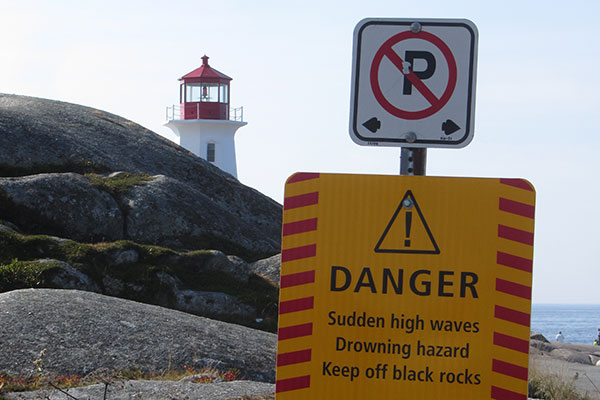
[[0, 0, 600, 303]]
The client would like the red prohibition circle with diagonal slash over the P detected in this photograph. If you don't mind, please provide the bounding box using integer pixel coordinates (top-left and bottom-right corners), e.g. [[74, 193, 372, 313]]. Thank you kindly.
[[371, 31, 456, 120]]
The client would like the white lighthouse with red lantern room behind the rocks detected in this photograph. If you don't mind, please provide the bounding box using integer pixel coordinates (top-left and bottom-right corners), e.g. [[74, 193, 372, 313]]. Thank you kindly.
[[165, 55, 247, 178]]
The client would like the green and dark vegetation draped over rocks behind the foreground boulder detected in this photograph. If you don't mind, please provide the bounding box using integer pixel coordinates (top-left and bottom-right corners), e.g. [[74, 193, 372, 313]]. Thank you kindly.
[[0, 230, 279, 332]]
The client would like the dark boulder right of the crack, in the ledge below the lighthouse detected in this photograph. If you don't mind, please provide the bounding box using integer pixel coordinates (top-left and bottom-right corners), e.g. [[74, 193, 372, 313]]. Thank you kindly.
[[124, 175, 279, 259]]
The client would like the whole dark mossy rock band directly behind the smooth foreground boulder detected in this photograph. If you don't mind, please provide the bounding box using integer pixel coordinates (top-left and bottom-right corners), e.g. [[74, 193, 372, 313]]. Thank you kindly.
[[0, 230, 278, 331]]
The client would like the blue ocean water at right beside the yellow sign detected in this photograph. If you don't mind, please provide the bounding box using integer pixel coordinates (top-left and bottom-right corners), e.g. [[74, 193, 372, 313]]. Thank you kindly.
[[531, 304, 600, 344]]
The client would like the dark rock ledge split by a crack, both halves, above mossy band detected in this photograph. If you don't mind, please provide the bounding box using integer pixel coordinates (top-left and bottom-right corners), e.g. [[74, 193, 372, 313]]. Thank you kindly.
[[0, 173, 279, 260]]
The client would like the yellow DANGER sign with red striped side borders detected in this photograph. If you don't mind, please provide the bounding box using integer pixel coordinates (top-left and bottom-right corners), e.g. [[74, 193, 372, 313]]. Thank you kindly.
[[276, 173, 535, 400]]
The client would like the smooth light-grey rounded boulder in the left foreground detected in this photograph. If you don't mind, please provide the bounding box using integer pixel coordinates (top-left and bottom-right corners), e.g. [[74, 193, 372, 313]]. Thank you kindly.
[[0, 289, 277, 382]]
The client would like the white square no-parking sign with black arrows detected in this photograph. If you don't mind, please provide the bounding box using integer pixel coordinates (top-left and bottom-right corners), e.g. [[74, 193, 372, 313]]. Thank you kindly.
[[350, 18, 478, 148]]
